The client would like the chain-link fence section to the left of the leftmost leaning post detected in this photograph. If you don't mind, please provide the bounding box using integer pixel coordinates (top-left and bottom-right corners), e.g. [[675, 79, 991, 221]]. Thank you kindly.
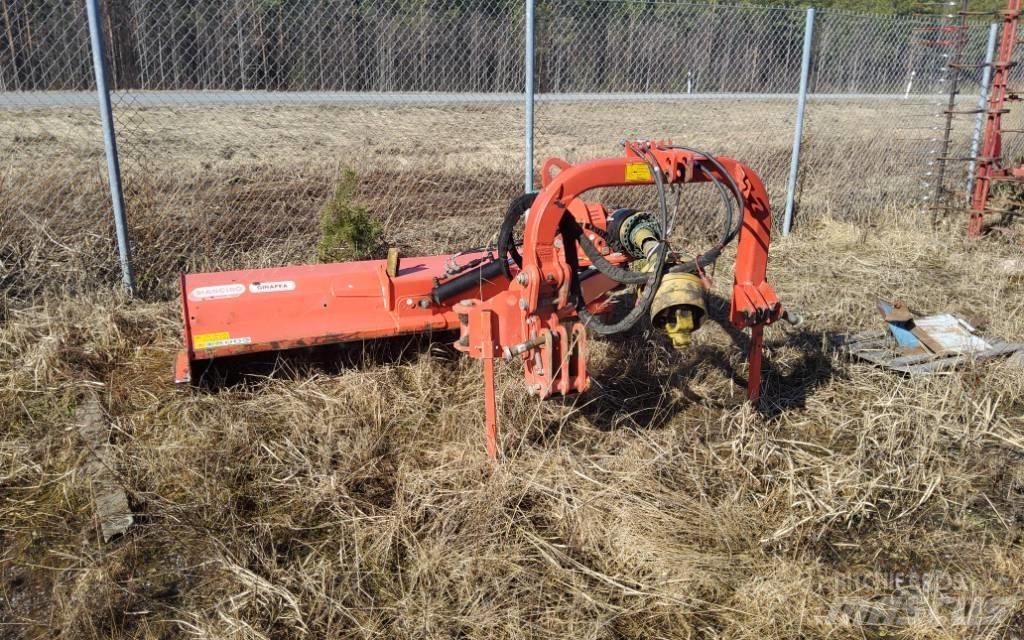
[[0, 0, 119, 299]]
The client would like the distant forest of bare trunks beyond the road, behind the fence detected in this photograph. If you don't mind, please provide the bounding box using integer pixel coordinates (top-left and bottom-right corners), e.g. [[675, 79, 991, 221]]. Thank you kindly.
[[0, 0, 992, 93]]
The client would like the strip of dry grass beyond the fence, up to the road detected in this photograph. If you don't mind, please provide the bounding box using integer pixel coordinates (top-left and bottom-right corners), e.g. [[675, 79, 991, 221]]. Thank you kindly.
[[0, 99, 999, 299]]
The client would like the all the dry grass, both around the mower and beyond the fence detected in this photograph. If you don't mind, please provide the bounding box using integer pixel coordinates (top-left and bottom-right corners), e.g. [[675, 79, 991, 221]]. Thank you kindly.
[[0, 97, 1024, 640]]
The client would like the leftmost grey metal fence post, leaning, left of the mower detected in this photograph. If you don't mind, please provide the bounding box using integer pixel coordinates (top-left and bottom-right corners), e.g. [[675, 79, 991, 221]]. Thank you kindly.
[[85, 0, 135, 295]]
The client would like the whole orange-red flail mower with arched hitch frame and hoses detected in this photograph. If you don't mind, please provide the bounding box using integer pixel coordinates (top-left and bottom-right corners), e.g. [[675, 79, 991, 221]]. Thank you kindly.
[[175, 140, 786, 458]]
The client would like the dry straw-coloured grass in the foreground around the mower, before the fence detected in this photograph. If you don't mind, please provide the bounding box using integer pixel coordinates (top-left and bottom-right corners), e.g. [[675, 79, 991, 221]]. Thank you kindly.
[[0, 214, 1024, 639]]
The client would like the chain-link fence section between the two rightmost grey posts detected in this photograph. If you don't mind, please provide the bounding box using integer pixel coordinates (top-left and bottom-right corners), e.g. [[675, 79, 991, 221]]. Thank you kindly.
[[800, 11, 988, 225]]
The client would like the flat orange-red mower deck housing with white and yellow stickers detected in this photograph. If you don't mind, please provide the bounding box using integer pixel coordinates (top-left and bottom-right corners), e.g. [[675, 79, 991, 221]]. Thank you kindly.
[[180, 254, 509, 382]]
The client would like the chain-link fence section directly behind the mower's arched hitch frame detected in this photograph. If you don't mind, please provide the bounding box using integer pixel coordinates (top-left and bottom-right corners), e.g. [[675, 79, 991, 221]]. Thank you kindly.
[[536, 2, 805, 246]]
